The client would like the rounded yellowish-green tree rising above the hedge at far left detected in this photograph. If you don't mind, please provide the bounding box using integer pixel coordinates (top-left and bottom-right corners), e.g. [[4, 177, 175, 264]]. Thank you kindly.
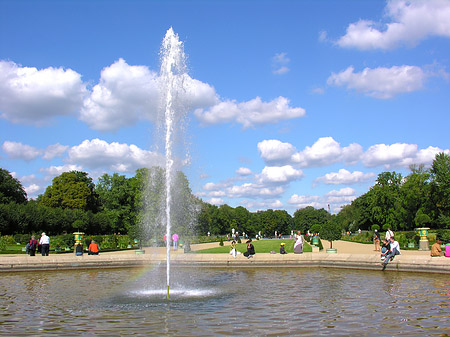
[[40, 171, 98, 212]]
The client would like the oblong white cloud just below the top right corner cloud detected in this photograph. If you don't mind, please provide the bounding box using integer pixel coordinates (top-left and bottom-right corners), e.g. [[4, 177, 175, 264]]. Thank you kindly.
[[327, 65, 428, 99]]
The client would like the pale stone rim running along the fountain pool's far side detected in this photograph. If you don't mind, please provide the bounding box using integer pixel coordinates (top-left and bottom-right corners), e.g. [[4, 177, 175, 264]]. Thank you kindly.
[[0, 253, 450, 274]]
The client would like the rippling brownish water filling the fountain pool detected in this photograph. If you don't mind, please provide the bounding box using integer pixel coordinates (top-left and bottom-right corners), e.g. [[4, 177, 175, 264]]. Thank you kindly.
[[0, 267, 450, 336]]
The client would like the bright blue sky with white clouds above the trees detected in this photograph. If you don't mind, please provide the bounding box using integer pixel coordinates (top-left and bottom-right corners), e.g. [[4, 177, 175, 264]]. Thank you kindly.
[[0, 0, 450, 214]]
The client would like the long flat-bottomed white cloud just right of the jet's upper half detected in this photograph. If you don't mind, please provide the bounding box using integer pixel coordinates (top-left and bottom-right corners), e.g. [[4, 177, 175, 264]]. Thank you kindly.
[[194, 97, 305, 129]]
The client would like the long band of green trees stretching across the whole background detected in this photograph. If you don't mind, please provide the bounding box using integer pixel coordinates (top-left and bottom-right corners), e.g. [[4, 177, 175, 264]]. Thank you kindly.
[[0, 153, 450, 239]]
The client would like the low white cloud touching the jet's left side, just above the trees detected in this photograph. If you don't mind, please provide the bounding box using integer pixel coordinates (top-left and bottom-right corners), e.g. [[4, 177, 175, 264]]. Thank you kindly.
[[68, 139, 165, 172]]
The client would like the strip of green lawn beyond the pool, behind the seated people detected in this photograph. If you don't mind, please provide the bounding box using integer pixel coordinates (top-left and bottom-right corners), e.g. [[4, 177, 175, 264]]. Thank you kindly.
[[195, 239, 312, 254]]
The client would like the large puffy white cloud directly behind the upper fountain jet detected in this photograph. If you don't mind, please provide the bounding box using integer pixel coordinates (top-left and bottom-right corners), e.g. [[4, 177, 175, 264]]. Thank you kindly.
[[80, 59, 218, 131]]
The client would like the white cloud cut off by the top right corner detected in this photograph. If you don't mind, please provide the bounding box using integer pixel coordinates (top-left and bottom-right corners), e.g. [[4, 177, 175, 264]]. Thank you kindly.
[[337, 0, 450, 50]]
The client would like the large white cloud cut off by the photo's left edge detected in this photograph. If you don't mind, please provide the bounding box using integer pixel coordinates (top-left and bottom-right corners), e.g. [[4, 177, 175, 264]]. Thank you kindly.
[[0, 61, 88, 126]]
